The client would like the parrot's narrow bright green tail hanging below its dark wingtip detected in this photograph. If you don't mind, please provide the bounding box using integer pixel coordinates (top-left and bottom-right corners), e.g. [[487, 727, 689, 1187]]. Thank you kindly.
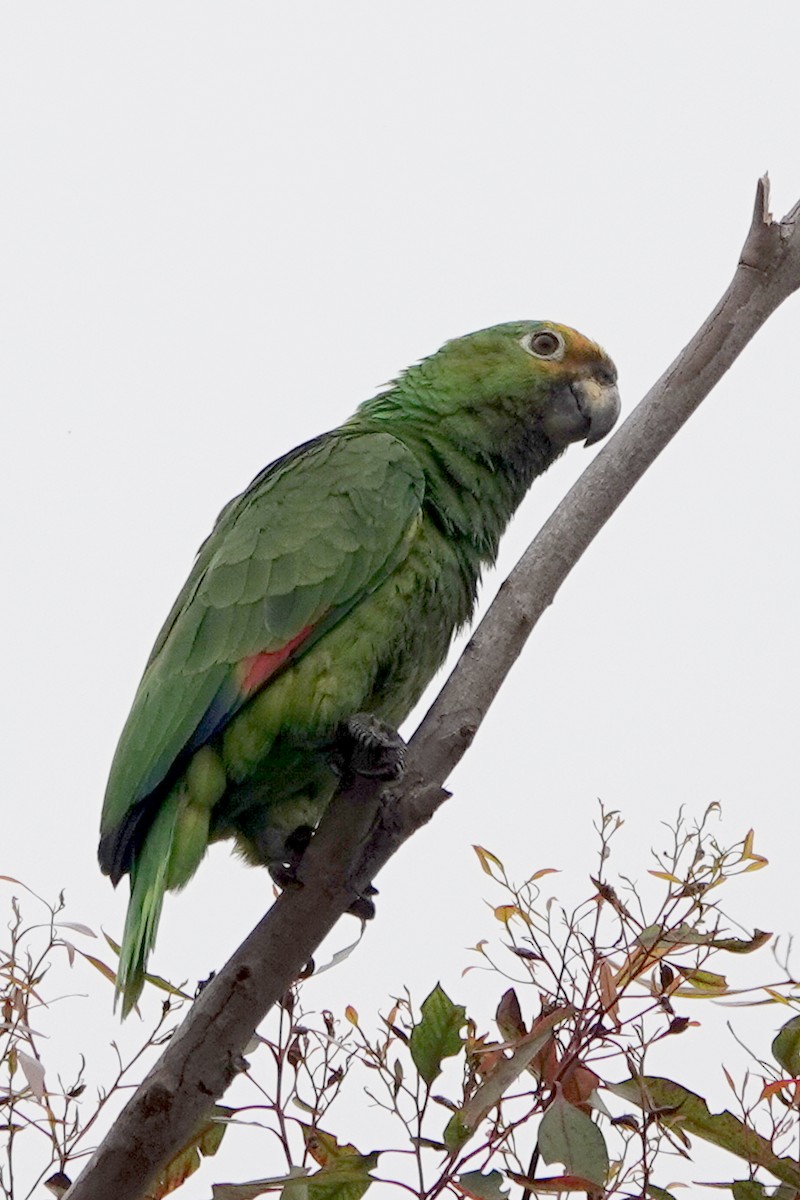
[[115, 793, 180, 1018]]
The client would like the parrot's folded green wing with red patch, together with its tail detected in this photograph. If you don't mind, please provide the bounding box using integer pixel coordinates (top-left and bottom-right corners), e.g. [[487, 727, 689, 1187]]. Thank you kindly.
[[101, 432, 423, 1012]]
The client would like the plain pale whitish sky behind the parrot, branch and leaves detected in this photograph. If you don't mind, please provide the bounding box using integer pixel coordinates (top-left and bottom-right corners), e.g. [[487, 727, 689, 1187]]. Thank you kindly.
[[0, 0, 800, 1200]]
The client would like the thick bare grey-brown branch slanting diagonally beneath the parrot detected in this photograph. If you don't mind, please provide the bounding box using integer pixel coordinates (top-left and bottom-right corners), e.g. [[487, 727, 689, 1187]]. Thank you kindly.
[[66, 176, 800, 1200]]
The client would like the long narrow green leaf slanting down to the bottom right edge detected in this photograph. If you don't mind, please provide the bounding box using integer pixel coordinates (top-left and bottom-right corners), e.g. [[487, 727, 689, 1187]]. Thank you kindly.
[[606, 1075, 800, 1188]]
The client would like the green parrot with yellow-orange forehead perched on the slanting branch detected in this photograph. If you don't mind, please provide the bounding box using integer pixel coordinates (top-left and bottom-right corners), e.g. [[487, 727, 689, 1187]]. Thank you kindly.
[[100, 322, 619, 1015]]
